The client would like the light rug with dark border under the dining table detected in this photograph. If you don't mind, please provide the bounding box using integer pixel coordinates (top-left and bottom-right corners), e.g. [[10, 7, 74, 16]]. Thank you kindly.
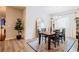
[[27, 39, 75, 52]]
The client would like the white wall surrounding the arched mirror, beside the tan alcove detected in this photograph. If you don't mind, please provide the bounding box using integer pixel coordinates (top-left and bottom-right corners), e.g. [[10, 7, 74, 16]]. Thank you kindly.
[[26, 7, 48, 39]]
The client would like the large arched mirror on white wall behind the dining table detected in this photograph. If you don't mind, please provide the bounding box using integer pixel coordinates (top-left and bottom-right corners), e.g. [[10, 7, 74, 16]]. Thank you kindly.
[[35, 17, 46, 37]]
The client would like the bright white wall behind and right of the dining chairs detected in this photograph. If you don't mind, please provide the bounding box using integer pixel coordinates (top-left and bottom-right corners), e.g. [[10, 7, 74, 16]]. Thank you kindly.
[[55, 14, 76, 38]]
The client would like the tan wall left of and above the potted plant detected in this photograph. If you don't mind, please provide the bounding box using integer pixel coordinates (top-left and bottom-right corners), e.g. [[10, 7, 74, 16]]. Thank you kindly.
[[5, 7, 23, 40]]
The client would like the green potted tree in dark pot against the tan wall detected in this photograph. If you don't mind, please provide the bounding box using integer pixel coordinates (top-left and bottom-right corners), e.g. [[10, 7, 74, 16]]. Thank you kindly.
[[15, 18, 23, 39]]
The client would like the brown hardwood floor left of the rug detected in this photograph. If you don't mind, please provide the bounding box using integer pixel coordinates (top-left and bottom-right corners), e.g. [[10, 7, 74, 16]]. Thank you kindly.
[[0, 39, 34, 52]]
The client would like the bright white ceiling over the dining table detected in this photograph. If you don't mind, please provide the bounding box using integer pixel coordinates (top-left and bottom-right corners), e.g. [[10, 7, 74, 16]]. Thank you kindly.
[[33, 6, 79, 14]]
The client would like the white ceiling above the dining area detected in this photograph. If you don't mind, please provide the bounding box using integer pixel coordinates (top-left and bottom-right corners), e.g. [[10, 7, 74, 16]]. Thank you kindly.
[[27, 6, 79, 15]]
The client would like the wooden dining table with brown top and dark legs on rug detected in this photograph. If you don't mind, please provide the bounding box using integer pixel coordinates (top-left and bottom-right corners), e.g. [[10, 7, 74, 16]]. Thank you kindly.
[[39, 32, 55, 50]]
